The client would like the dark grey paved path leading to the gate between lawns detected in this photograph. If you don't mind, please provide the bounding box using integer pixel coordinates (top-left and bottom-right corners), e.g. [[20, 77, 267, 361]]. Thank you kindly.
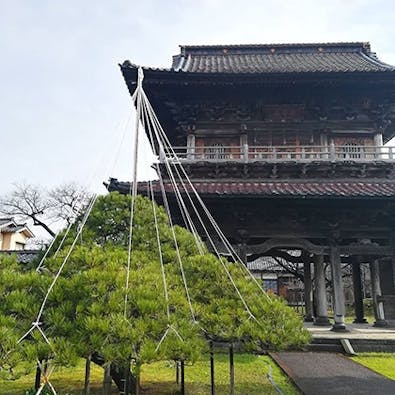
[[271, 352, 395, 395]]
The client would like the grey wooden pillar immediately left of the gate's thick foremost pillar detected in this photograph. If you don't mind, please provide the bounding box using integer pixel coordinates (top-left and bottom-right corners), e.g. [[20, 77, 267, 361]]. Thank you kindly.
[[314, 255, 330, 326]]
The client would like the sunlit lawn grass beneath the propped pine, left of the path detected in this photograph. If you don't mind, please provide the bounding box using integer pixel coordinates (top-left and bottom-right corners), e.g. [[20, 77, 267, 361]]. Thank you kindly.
[[0, 354, 299, 395]]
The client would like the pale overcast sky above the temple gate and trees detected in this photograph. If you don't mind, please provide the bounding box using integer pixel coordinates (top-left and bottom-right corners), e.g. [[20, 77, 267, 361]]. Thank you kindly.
[[0, 0, 395, 198]]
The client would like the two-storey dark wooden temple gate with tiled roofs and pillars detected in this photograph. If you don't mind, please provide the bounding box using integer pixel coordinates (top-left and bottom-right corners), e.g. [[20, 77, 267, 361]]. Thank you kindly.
[[108, 43, 395, 330]]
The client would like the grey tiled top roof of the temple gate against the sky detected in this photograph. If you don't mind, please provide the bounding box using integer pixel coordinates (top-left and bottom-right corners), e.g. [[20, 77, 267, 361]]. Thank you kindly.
[[122, 43, 395, 74]]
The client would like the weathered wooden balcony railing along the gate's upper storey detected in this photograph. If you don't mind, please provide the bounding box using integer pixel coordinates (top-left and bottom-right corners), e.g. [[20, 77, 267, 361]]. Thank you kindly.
[[160, 144, 395, 163]]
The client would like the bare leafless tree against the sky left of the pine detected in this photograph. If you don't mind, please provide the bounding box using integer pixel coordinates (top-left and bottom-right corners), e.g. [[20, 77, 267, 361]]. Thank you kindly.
[[0, 183, 90, 237]]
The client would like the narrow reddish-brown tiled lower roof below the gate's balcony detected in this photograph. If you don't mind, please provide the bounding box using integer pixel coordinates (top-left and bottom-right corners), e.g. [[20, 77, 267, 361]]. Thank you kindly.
[[108, 179, 395, 198]]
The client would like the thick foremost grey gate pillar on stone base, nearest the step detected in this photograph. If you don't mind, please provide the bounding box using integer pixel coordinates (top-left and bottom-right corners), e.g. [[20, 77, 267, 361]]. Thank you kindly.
[[330, 246, 347, 331]]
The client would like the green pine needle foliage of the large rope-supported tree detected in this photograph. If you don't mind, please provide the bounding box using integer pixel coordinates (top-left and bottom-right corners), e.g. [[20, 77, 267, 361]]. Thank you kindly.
[[0, 193, 309, 377]]
